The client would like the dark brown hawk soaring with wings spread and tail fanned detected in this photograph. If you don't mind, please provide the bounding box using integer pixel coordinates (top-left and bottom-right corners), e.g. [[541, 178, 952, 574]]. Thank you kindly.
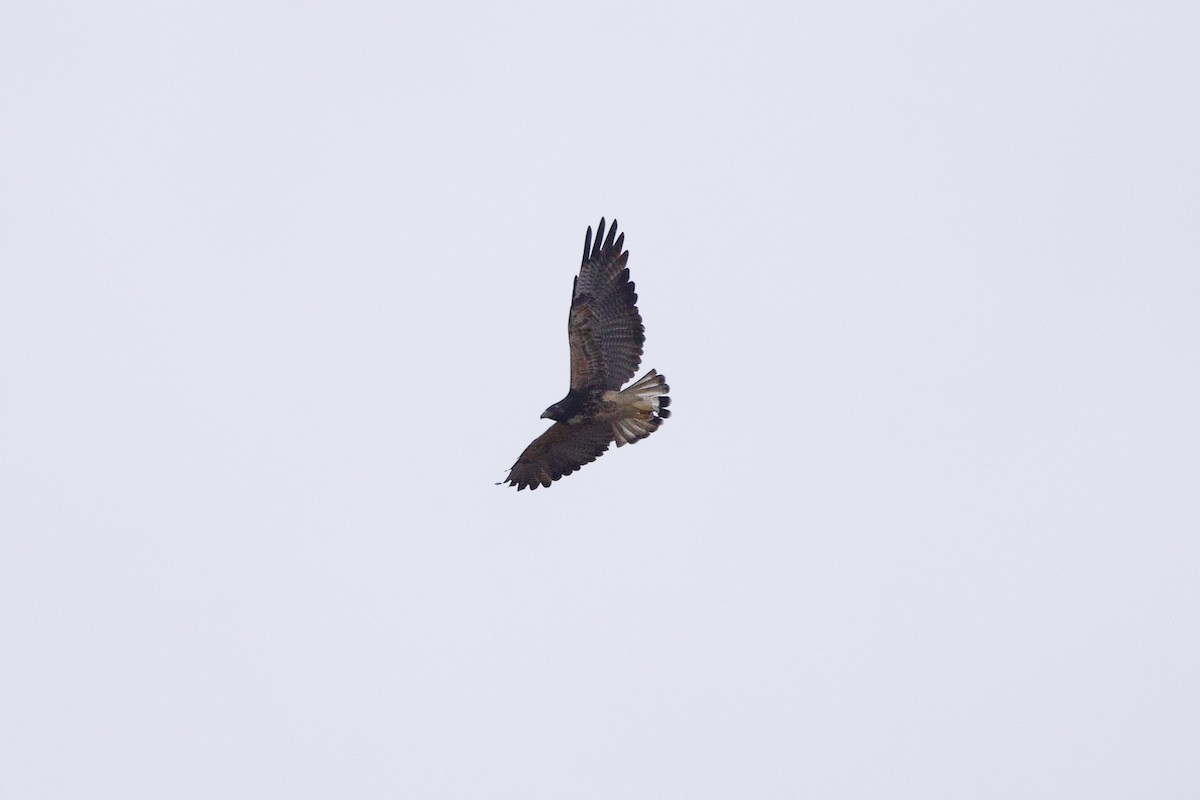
[[502, 219, 671, 489]]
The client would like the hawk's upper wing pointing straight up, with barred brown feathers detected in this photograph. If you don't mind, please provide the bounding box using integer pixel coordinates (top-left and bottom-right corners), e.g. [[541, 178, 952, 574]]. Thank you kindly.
[[566, 219, 646, 389]]
